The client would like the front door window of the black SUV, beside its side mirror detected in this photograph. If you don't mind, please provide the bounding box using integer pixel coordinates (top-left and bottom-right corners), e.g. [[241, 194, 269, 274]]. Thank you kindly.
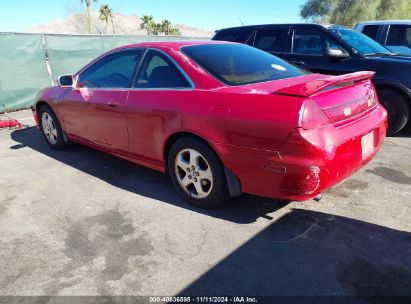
[[292, 29, 346, 55]]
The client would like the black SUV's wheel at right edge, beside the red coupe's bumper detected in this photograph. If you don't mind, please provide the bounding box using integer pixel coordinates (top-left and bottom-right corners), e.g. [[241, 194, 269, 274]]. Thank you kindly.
[[378, 89, 410, 135]]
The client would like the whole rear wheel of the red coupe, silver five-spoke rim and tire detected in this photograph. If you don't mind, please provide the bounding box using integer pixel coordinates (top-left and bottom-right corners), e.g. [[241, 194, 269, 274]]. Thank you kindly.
[[168, 136, 228, 208]]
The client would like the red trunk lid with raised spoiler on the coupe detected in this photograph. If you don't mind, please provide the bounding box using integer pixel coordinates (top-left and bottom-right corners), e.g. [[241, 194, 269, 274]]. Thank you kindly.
[[218, 71, 378, 126]]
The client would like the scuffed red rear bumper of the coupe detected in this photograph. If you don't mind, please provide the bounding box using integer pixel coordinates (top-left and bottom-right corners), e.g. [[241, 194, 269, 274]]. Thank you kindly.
[[216, 105, 387, 201]]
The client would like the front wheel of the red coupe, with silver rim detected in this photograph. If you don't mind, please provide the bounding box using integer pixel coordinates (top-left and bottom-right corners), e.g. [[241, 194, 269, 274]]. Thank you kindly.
[[39, 105, 67, 150]]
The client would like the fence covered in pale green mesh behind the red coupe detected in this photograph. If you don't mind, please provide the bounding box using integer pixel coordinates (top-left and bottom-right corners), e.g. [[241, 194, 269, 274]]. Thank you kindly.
[[0, 33, 209, 111]]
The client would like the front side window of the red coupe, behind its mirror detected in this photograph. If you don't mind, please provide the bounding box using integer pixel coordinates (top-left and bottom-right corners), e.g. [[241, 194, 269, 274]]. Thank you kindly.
[[79, 49, 143, 88]]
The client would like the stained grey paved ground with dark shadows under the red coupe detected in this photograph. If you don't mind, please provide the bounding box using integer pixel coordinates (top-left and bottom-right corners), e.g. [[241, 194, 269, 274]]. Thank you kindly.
[[0, 111, 411, 296]]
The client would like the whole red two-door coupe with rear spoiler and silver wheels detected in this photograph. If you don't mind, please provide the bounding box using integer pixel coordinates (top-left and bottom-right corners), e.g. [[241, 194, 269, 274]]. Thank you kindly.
[[33, 41, 387, 208]]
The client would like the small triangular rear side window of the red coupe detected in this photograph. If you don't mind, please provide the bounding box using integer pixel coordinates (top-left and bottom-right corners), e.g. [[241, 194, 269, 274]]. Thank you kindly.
[[135, 50, 191, 89]]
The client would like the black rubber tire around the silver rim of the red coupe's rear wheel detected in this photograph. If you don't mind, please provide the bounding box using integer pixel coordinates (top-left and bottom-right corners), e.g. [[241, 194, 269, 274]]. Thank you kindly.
[[167, 136, 229, 209]]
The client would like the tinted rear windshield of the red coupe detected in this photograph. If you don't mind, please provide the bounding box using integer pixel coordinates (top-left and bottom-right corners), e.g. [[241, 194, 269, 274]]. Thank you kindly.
[[182, 44, 307, 85]]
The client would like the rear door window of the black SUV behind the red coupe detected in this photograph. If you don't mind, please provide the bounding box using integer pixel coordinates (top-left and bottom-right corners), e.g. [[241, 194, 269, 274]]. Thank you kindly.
[[254, 28, 291, 53]]
